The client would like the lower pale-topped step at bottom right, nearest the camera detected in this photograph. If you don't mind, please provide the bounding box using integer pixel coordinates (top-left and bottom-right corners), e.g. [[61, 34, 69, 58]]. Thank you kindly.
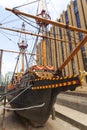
[[54, 104, 87, 130]]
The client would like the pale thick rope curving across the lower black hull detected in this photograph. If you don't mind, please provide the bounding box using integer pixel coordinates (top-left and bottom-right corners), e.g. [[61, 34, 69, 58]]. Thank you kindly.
[[0, 103, 45, 111]]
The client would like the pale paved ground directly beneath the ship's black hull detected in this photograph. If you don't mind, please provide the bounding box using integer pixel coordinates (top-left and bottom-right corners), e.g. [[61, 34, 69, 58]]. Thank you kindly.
[[0, 109, 79, 130]]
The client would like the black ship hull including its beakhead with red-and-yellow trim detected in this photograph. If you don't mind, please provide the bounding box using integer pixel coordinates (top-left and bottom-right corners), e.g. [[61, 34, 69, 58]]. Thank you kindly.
[[8, 67, 80, 127]]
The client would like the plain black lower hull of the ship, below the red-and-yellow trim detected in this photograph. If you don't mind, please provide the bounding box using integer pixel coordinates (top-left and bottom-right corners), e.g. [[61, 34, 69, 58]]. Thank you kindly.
[[9, 84, 59, 127]]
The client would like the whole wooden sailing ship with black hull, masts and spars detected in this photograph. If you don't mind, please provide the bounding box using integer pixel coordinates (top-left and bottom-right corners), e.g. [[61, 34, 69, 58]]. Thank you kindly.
[[0, 0, 87, 127]]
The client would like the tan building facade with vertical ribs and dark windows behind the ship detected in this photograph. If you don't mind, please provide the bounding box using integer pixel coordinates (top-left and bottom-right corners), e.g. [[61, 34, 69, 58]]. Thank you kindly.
[[37, 0, 87, 76]]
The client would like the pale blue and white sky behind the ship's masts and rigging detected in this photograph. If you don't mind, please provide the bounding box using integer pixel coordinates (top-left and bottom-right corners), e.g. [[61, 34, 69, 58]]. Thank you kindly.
[[0, 0, 71, 75]]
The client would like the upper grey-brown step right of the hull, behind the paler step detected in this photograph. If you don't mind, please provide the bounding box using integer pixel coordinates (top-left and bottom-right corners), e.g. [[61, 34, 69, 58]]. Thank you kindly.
[[56, 93, 87, 114]]
